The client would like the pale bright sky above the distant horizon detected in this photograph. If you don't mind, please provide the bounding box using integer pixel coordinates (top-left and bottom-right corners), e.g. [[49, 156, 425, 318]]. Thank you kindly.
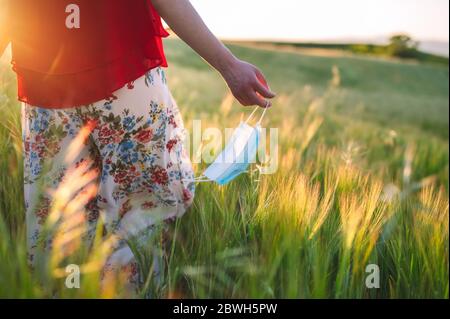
[[191, 0, 449, 42]]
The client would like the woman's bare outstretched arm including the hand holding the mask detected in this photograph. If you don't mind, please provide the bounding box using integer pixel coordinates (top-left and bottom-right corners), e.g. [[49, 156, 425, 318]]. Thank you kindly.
[[151, 0, 275, 107]]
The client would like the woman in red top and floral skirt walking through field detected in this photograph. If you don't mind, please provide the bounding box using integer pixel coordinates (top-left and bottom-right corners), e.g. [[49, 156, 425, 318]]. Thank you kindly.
[[0, 0, 275, 290]]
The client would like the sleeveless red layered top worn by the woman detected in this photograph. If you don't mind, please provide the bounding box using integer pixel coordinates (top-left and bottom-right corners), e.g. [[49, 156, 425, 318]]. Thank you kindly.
[[0, 0, 168, 108]]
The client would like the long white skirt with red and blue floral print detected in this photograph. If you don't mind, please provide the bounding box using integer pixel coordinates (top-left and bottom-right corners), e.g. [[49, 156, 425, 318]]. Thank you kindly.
[[22, 68, 194, 288]]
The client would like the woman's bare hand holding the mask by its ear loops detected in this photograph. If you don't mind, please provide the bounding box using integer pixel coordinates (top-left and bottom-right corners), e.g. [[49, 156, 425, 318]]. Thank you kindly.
[[220, 59, 275, 108]]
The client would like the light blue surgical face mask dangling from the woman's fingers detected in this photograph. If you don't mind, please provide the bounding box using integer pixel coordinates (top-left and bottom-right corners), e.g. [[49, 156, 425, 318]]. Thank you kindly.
[[191, 107, 267, 185]]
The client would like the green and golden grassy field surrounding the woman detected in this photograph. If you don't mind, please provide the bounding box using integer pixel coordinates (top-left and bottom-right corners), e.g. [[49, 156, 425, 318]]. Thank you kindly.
[[0, 40, 449, 298]]
